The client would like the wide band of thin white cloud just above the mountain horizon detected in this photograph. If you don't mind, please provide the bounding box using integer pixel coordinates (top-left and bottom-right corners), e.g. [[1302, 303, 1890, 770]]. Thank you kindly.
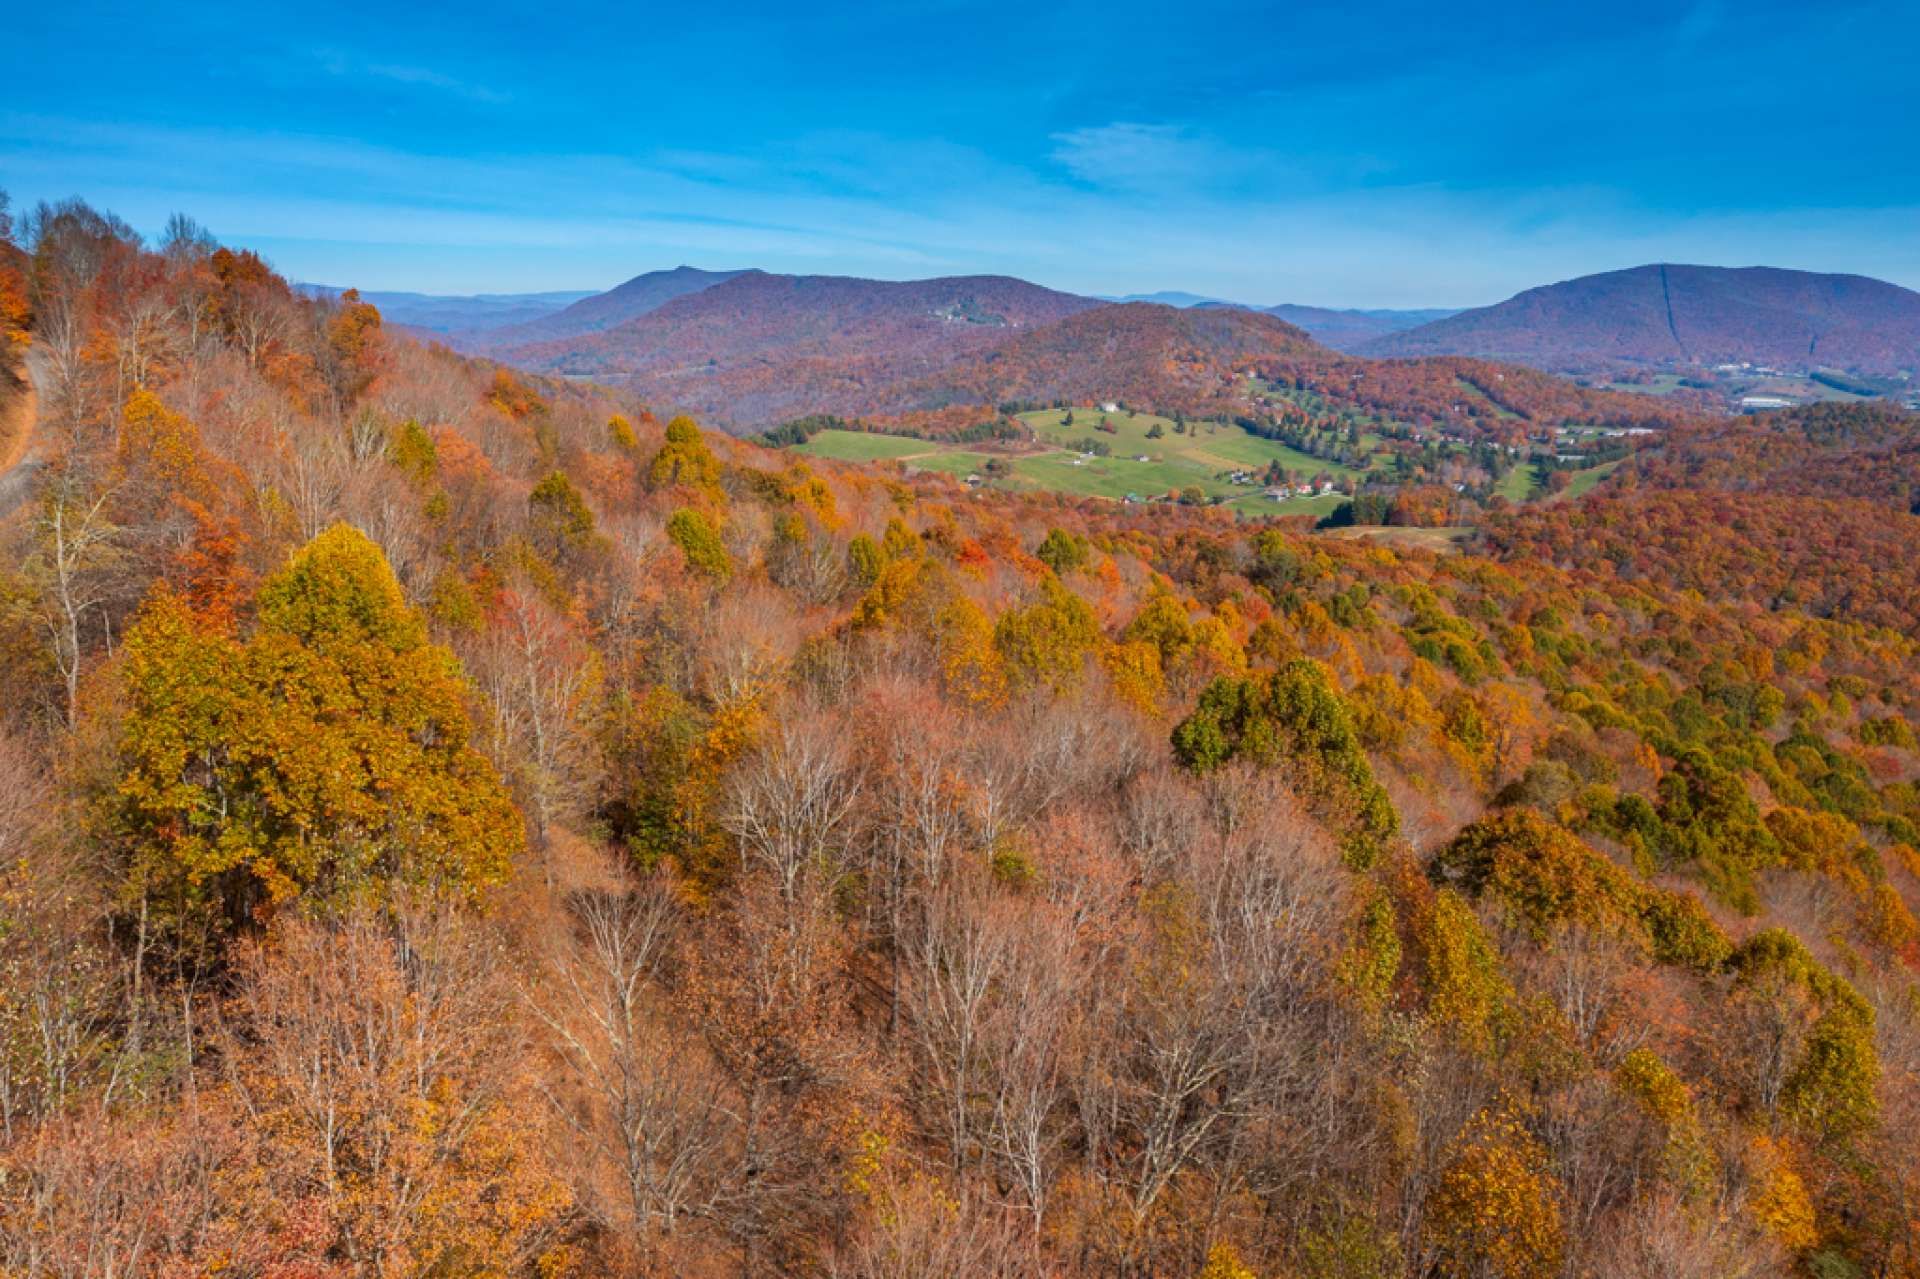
[[0, 109, 1920, 305]]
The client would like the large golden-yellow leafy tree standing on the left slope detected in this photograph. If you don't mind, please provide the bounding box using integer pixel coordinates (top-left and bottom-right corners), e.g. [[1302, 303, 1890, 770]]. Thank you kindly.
[[104, 526, 524, 928]]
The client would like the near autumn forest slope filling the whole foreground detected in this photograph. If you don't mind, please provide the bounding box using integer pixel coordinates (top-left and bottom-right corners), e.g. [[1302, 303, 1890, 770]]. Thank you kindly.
[[0, 192, 1920, 1279]]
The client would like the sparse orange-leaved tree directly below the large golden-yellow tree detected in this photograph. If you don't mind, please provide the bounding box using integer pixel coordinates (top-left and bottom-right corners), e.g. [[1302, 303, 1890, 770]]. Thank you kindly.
[[221, 901, 564, 1273]]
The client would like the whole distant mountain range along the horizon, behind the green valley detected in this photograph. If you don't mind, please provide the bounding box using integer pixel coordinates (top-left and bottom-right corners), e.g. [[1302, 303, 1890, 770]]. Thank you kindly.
[[345, 265, 1920, 430]]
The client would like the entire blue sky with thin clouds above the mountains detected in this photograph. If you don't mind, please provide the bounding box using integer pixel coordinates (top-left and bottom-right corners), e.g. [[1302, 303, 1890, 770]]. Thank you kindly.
[[0, 0, 1920, 305]]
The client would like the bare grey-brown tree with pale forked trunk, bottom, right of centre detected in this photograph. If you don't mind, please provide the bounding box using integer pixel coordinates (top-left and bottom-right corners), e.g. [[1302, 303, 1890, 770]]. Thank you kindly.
[[1079, 793, 1346, 1271]]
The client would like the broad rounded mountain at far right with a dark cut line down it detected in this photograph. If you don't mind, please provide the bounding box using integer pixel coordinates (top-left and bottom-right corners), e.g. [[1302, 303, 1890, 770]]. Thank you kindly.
[[1357, 265, 1920, 373]]
